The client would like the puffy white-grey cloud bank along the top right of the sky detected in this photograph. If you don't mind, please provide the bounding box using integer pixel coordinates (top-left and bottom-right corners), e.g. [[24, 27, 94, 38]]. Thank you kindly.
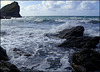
[[42, 1, 98, 11]]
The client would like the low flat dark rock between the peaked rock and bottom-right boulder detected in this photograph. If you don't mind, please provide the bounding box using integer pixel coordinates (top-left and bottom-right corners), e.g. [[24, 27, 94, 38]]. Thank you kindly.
[[59, 36, 100, 48]]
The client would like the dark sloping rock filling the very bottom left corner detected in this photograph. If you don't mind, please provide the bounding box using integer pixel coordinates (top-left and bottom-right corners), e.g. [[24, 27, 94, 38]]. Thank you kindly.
[[0, 61, 20, 72]]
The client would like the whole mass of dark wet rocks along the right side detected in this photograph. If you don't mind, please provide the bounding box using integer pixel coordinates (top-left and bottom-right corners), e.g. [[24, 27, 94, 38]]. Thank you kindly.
[[56, 26, 100, 72]]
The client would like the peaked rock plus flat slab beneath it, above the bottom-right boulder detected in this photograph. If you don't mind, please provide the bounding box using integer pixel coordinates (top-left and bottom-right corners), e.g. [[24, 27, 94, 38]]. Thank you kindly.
[[57, 26, 100, 49]]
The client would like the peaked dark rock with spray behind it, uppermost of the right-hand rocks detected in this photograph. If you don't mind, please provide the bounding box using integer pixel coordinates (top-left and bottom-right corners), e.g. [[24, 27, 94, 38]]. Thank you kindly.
[[57, 26, 84, 39]]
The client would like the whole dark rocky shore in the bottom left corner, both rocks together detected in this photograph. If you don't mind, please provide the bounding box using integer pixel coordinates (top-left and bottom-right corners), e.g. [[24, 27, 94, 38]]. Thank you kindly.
[[0, 46, 20, 72]]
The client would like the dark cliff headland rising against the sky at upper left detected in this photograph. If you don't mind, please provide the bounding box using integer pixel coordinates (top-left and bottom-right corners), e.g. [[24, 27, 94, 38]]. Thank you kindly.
[[0, 2, 21, 18]]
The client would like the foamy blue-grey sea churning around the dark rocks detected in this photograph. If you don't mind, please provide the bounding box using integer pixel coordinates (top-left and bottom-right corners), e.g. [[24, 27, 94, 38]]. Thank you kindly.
[[1, 16, 100, 72]]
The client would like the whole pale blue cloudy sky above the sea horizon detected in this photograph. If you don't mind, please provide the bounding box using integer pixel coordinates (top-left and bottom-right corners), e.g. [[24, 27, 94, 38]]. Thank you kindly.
[[0, 1, 99, 16]]
